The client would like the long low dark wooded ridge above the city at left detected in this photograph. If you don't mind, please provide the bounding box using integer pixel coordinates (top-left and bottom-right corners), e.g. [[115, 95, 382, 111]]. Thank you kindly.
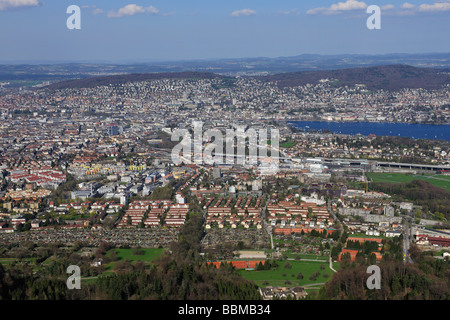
[[46, 71, 225, 90]]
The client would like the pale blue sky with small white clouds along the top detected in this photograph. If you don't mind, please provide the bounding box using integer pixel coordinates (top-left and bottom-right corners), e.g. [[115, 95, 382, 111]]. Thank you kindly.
[[0, 0, 450, 62]]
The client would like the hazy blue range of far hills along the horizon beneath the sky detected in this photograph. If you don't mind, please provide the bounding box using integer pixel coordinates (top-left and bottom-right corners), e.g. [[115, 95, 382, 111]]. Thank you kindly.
[[0, 52, 450, 88]]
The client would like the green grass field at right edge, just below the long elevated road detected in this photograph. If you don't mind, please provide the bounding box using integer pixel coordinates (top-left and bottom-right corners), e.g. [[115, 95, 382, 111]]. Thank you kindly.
[[366, 172, 450, 191]]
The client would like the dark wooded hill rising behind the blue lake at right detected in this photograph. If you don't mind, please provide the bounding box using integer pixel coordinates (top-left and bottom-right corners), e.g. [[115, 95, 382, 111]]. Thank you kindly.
[[256, 64, 450, 90]]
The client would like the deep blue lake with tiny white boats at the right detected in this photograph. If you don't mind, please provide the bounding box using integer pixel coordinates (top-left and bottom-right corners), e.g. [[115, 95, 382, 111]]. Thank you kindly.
[[289, 121, 450, 141]]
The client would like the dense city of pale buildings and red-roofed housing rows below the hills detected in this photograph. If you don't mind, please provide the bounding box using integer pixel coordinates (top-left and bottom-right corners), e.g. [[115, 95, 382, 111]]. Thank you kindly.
[[0, 65, 450, 300]]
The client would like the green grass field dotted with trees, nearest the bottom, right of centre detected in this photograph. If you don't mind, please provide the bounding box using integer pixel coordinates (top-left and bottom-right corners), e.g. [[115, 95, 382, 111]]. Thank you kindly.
[[239, 260, 336, 287]]
